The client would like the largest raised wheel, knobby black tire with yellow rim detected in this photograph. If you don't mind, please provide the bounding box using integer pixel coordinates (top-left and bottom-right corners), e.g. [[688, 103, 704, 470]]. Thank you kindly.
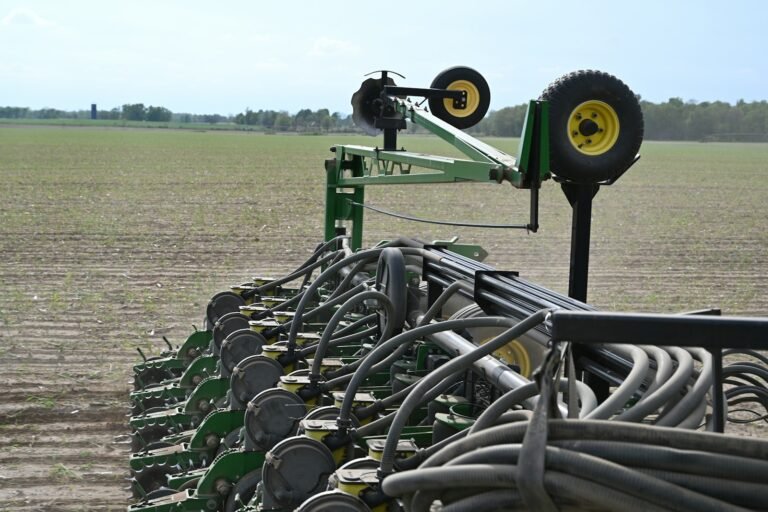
[[540, 70, 643, 183]]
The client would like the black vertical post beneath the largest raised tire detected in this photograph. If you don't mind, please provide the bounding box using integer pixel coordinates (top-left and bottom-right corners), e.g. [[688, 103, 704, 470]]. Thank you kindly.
[[562, 183, 600, 302]]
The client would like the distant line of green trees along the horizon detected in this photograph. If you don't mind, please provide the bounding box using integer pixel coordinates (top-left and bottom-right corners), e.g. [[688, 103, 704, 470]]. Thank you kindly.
[[0, 98, 768, 141]]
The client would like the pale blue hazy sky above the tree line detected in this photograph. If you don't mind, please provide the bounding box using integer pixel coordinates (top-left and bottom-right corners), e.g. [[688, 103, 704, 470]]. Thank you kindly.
[[0, 0, 768, 115]]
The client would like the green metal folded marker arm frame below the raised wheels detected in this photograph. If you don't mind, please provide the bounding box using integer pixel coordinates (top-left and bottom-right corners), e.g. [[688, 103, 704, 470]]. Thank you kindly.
[[325, 98, 550, 250]]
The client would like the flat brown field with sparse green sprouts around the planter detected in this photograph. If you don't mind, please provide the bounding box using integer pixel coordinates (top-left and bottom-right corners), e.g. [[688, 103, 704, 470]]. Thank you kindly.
[[0, 128, 768, 511]]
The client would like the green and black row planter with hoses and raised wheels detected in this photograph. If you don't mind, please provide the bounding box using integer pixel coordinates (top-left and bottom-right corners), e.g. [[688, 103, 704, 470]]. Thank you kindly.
[[128, 67, 768, 512]]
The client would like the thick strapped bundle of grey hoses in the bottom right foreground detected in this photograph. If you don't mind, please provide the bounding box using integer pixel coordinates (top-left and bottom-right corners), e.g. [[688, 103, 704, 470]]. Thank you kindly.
[[382, 420, 768, 512]]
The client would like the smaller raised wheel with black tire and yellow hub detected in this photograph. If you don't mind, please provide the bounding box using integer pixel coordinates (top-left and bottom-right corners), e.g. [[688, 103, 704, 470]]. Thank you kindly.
[[429, 66, 491, 130]]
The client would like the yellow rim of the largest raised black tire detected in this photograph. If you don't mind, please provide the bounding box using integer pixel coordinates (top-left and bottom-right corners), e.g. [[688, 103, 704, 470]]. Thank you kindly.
[[567, 100, 620, 156]]
